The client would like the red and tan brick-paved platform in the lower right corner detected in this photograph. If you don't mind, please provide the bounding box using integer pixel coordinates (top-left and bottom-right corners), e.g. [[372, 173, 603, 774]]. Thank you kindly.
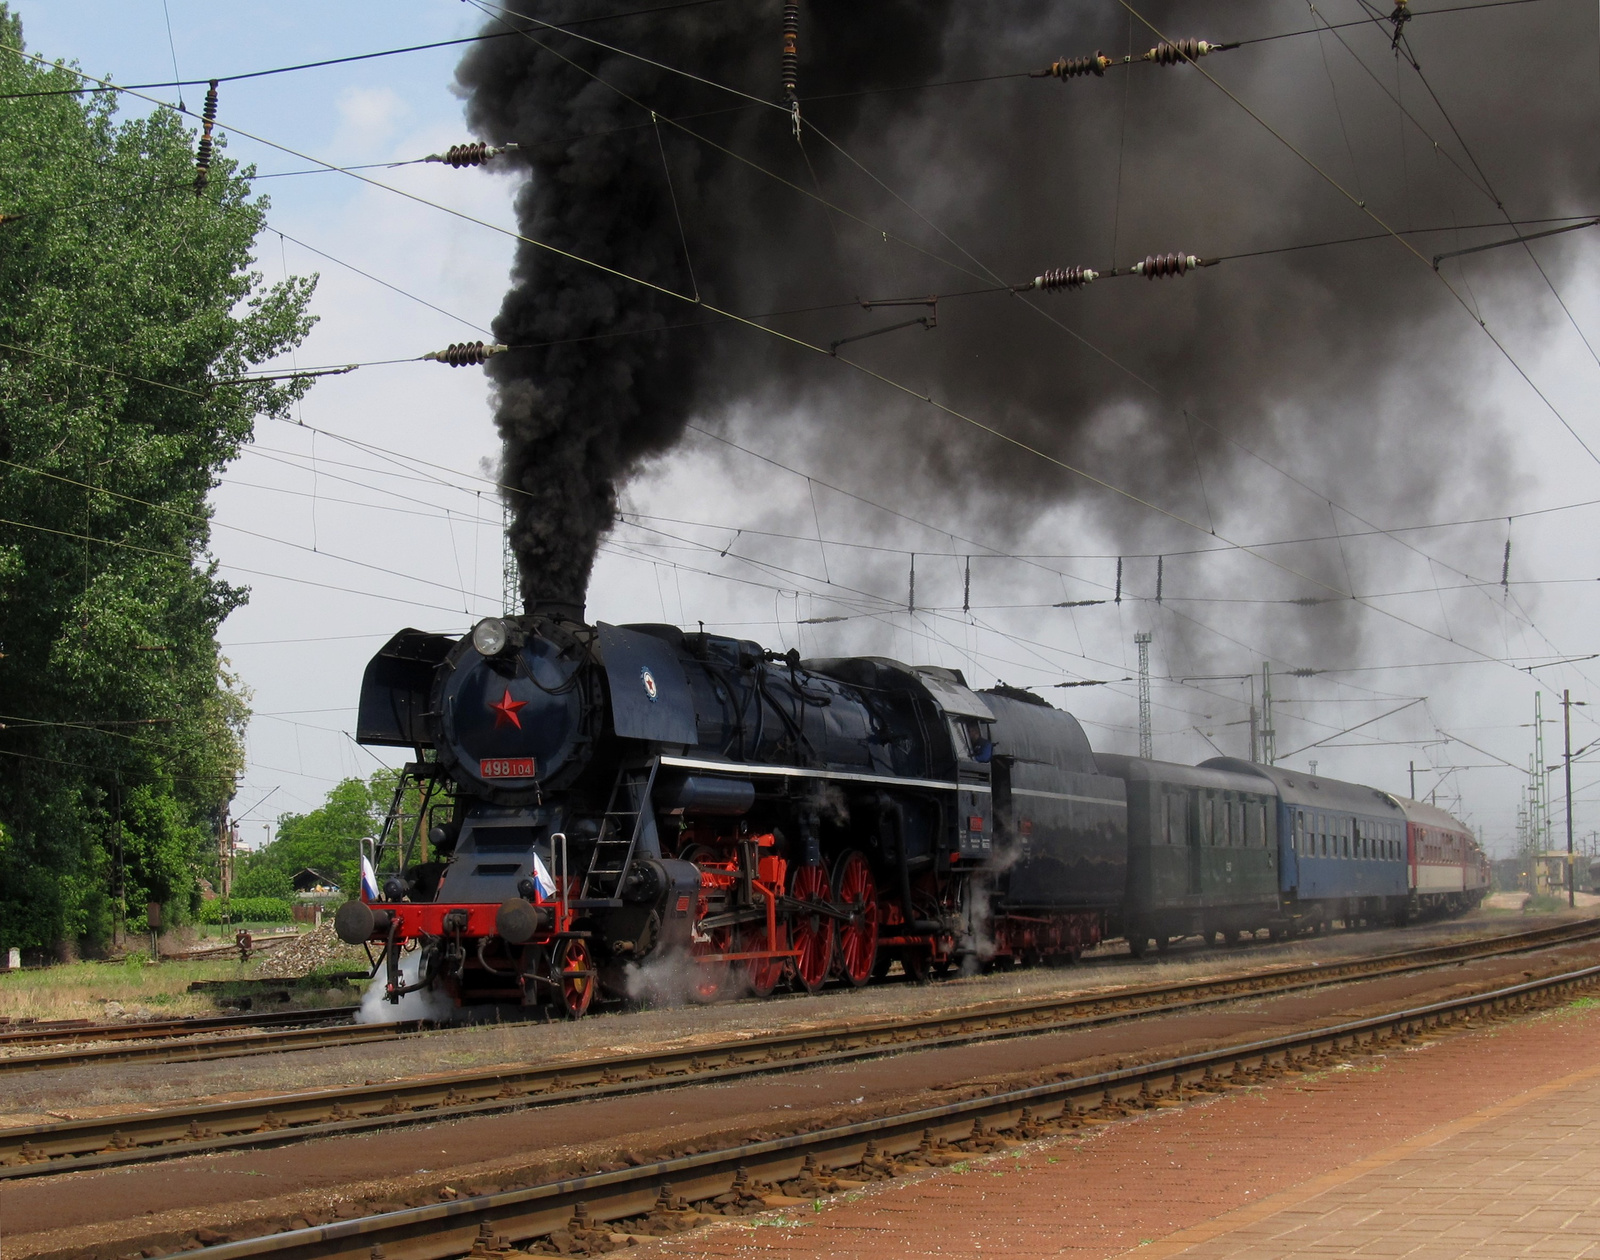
[[630, 1003, 1600, 1260]]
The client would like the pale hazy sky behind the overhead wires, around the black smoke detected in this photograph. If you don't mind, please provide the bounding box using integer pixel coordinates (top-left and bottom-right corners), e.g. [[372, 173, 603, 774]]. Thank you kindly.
[[13, 0, 1600, 852]]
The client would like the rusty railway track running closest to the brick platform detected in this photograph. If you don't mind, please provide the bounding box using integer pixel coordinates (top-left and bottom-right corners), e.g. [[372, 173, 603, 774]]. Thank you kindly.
[[147, 966, 1600, 1260]]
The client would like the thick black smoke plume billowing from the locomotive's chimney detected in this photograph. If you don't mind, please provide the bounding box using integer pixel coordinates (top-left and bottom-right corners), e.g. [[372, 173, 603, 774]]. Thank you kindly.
[[459, 0, 1597, 627]]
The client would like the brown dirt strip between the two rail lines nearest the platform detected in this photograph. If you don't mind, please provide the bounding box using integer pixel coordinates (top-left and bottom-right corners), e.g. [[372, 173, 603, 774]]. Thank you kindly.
[[12, 921, 1600, 1257]]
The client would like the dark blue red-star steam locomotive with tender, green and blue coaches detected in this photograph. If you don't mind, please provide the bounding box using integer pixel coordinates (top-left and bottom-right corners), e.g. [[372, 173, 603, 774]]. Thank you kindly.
[[336, 604, 1486, 1017]]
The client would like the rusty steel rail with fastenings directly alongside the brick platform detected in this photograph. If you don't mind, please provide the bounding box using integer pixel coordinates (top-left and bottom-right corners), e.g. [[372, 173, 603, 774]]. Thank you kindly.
[[171, 966, 1600, 1260]]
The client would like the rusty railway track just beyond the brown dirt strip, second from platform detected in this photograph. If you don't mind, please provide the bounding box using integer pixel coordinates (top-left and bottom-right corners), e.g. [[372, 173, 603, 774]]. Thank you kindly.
[[0, 919, 1600, 1180]]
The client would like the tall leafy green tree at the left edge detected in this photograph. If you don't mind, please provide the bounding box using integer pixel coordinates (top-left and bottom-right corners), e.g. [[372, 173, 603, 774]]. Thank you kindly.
[[0, 2, 314, 948]]
